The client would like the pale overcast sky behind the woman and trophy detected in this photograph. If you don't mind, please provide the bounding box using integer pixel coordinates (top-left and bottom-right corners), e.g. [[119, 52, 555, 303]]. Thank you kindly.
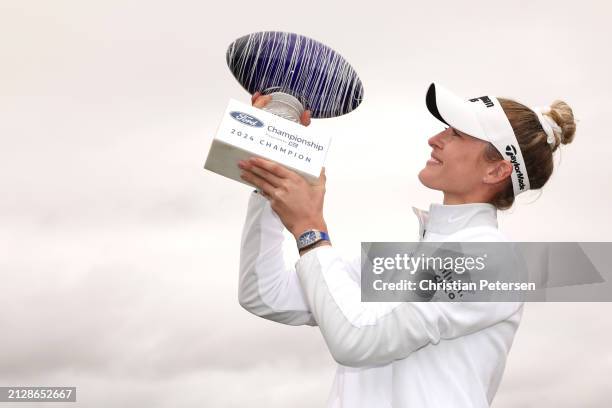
[[0, 0, 612, 408]]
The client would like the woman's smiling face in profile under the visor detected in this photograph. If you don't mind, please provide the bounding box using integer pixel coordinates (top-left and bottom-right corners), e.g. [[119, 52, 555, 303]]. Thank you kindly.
[[419, 128, 488, 196]]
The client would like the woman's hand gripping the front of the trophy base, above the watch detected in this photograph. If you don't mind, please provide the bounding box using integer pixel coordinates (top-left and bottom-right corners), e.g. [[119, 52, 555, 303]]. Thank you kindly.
[[238, 157, 327, 239]]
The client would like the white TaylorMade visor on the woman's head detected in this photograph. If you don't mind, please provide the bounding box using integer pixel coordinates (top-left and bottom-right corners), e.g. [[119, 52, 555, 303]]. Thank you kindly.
[[425, 83, 529, 197]]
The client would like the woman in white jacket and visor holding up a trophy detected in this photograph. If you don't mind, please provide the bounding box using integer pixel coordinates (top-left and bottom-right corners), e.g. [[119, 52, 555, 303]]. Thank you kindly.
[[234, 84, 575, 408]]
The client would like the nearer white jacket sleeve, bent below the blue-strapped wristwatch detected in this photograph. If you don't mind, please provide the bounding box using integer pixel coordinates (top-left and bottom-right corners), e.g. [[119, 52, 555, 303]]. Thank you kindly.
[[296, 246, 522, 367]]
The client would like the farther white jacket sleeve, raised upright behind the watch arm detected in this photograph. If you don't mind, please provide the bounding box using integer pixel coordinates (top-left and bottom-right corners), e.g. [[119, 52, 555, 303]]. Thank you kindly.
[[238, 192, 316, 325]]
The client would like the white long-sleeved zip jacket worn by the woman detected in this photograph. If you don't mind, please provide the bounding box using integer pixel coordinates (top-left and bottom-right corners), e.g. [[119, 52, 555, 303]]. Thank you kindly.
[[239, 193, 523, 408]]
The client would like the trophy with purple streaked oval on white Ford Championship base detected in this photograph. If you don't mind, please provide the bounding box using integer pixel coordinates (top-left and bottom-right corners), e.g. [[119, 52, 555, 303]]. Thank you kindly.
[[204, 31, 363, 181]]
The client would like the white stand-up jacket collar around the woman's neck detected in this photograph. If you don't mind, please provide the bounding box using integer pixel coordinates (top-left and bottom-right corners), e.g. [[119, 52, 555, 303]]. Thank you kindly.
[[412, 203, 497, 239]]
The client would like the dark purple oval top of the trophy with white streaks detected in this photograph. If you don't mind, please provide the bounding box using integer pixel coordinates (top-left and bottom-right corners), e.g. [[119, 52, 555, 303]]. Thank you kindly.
[[226, 31, 363, 121]]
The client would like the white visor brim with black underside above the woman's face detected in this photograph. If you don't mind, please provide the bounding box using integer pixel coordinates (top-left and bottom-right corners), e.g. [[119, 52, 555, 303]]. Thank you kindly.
[[425, 82, 487, 140]]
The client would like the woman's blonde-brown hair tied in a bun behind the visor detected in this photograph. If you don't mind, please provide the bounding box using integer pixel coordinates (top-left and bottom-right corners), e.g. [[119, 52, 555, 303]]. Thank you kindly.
[[484, 98, 576, 210]]
